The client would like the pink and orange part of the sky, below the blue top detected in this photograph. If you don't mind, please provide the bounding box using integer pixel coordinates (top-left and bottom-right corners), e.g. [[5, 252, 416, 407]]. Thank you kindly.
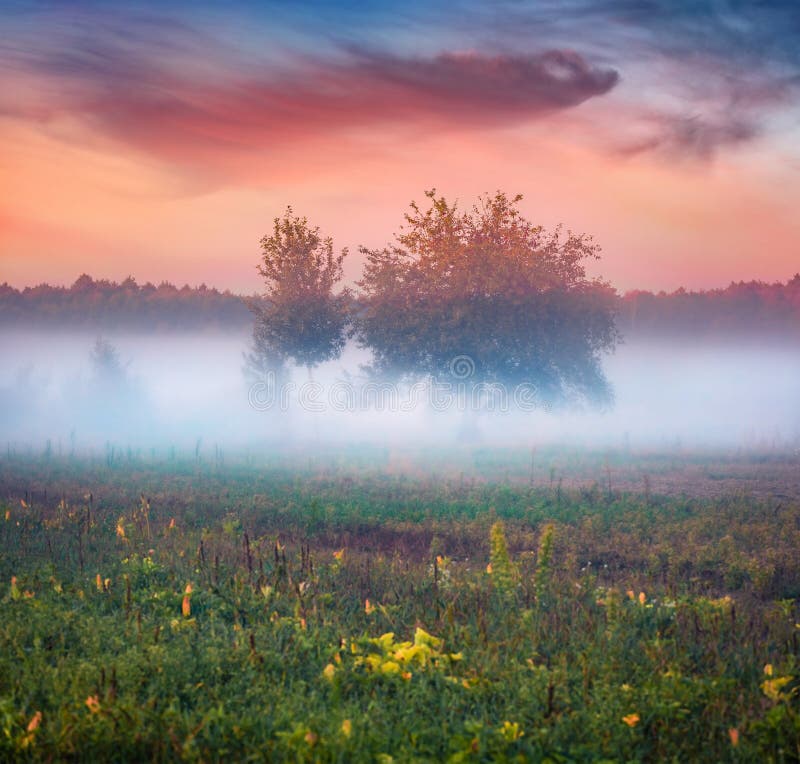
[[0, 3, 800, 292]]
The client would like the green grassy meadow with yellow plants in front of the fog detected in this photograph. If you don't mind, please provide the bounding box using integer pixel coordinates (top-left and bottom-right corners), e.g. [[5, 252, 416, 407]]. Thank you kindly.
[[0, 448, 800, 762]]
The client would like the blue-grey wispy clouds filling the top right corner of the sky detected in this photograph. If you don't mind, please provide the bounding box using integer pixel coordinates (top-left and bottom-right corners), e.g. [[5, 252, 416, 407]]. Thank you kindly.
[[464, 0, 800, 161]]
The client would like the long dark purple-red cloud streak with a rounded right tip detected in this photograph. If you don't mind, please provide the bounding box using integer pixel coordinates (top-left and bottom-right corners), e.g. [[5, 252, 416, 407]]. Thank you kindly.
[[0, 10, 619, 172]]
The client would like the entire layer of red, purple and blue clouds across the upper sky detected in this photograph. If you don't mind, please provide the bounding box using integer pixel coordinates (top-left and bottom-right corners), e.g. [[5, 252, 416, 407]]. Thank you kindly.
[[0, 0, 800, 175]]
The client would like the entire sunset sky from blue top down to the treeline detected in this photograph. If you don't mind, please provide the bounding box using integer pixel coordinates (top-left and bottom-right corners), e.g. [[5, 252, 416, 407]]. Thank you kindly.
[[0, 0, 800, 293]]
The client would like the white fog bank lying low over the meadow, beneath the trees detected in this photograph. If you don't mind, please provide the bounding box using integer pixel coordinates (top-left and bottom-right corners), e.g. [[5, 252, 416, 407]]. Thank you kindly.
[[0, 330, 800, 452]]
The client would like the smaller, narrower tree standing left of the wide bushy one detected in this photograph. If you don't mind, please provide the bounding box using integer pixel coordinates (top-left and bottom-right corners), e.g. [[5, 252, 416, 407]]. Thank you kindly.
[[250, 207, 348, 373]]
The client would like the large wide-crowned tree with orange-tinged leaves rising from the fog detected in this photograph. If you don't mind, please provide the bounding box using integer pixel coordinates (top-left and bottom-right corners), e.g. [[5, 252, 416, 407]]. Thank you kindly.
[[356, 191, 617, 404]]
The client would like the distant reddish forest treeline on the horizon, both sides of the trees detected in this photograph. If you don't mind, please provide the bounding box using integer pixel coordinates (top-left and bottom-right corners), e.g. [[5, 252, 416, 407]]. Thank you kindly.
[[0, 274, 800, 337]]
